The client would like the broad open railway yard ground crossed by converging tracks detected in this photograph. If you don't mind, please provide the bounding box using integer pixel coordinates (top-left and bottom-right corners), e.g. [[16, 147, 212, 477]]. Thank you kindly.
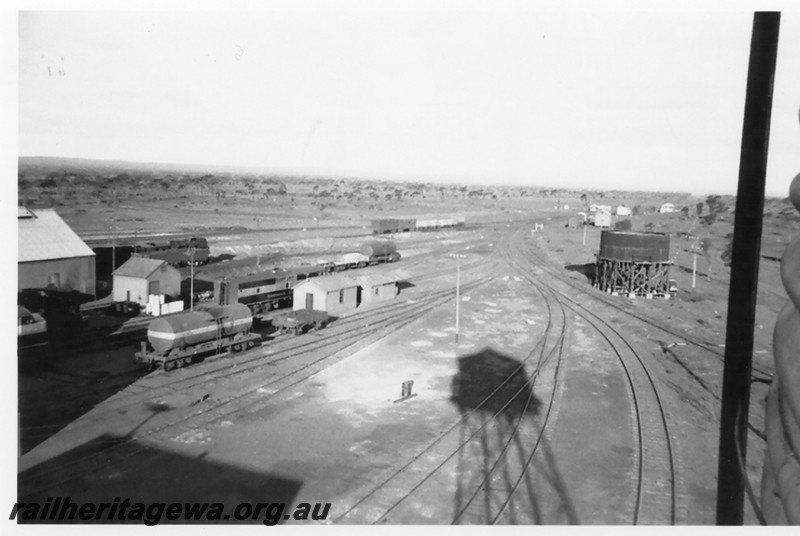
[[18, 191, 796, 525]]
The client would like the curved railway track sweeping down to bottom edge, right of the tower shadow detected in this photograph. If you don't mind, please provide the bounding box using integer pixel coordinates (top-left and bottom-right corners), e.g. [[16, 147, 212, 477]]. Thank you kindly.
[[512, 229, 678, 525]]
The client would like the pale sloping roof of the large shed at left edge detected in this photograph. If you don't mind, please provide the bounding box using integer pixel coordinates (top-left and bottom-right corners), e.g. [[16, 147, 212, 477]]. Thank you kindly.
[[17, 207, 94, 262]]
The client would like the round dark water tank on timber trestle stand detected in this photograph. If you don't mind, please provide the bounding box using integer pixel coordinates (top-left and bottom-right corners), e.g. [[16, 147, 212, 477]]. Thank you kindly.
[[595, 231, 674, 298]]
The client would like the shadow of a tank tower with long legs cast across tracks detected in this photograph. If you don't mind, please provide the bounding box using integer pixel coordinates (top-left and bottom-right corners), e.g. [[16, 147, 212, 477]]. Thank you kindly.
[[450, 348, 579, 524]]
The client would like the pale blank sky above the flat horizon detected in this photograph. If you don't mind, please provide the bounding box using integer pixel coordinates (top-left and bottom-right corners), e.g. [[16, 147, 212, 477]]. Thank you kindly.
[[9, 1, 800, 196]]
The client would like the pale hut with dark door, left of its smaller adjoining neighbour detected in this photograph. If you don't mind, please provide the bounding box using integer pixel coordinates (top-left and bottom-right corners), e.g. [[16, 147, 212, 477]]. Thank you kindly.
[[292, 275, 360, 315]]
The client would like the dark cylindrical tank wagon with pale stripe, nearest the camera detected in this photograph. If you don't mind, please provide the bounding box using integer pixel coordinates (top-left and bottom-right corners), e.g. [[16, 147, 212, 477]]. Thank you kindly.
[[134, 304, 261, 370]]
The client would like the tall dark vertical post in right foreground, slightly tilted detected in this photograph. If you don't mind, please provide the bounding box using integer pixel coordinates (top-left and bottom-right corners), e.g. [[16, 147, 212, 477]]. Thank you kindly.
[[717, 12, 780, 525]]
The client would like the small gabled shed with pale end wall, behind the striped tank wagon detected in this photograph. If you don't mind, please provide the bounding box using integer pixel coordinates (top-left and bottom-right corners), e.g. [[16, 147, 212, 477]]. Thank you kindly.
[[112, 257, 181, 306]]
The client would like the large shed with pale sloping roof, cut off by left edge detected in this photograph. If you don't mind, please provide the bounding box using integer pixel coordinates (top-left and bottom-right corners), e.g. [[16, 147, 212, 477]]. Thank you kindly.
[[17, 207, 96, 296]]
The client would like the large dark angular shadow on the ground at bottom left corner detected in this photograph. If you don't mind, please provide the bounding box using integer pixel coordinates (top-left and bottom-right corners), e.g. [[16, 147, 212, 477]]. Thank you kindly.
[[17, 404, 302, 525]]
